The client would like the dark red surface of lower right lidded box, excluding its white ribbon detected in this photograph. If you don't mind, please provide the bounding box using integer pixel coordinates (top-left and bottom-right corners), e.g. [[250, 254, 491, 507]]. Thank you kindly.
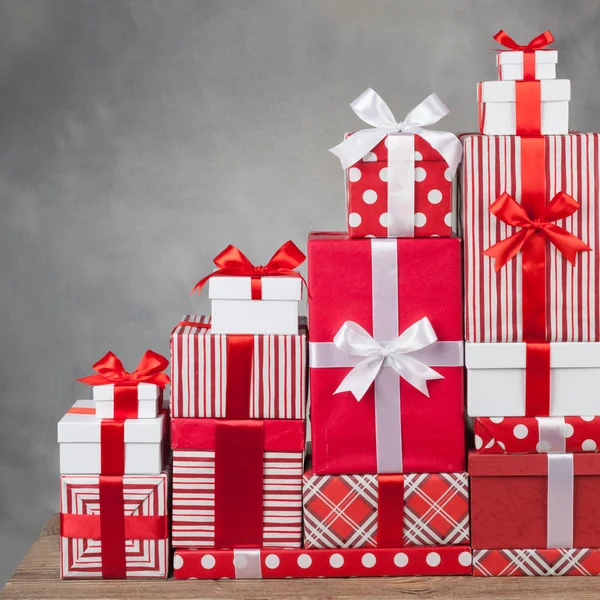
[[469, 454, 600, 549]]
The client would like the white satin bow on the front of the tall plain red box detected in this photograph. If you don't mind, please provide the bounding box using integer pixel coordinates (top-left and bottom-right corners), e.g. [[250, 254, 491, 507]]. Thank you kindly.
[[333, 317, 444, 400]]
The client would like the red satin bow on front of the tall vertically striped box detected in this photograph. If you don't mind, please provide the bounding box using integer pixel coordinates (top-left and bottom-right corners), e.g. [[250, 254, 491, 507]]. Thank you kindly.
[[483, 192, 591, 272]]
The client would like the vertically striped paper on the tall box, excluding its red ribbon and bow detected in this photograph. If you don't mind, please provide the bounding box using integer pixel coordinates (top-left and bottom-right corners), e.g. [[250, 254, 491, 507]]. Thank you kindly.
[[462, 133, 600, 342]]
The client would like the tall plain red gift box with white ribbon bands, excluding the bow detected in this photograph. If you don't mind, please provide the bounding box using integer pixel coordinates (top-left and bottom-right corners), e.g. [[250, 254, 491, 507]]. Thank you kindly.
[[308, 233, 465, 474]]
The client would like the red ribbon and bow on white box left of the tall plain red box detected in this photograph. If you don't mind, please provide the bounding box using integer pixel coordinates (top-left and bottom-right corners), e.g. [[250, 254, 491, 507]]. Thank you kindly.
[[192, 241, 308, 300]]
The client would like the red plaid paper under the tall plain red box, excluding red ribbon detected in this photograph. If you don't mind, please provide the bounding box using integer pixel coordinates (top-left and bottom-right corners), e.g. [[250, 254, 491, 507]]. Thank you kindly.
[[303, 472, 469, 548]]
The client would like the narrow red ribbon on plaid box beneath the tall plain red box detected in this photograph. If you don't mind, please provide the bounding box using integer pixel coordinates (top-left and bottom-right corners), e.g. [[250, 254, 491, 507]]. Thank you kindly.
[[377, 475, 404, 548]]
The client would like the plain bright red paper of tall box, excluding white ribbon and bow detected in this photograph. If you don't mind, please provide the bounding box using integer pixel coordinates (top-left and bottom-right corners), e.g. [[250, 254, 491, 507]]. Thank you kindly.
[[308, 233, 465, 474]]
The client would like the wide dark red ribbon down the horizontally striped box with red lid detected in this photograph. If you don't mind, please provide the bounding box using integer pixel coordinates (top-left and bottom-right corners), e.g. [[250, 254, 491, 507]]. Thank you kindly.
[[215, 420, 264, 548]]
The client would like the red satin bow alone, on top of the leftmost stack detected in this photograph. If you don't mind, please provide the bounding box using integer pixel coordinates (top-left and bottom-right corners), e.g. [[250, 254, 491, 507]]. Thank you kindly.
[[77, 350, 171, 388]]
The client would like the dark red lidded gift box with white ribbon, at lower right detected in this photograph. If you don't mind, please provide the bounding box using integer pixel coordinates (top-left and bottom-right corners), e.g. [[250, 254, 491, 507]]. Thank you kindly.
[[469, 453, 600, 549]]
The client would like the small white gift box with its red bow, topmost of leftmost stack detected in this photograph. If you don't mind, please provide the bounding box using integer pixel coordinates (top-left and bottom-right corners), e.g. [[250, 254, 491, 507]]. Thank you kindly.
[[77, 350, 171, 419]]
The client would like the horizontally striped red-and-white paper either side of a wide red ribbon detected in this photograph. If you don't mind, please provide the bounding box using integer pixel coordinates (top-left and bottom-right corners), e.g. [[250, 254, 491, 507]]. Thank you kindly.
[[172, 449, 303, 548]]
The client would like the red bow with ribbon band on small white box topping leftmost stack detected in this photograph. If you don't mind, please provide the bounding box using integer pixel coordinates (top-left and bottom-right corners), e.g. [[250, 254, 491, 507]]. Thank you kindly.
[[77, 350, 171, 419]]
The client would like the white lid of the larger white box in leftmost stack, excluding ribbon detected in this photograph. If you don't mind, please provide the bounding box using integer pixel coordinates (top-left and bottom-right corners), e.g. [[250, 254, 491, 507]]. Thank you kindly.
[[58, 400, 167, 444]]
